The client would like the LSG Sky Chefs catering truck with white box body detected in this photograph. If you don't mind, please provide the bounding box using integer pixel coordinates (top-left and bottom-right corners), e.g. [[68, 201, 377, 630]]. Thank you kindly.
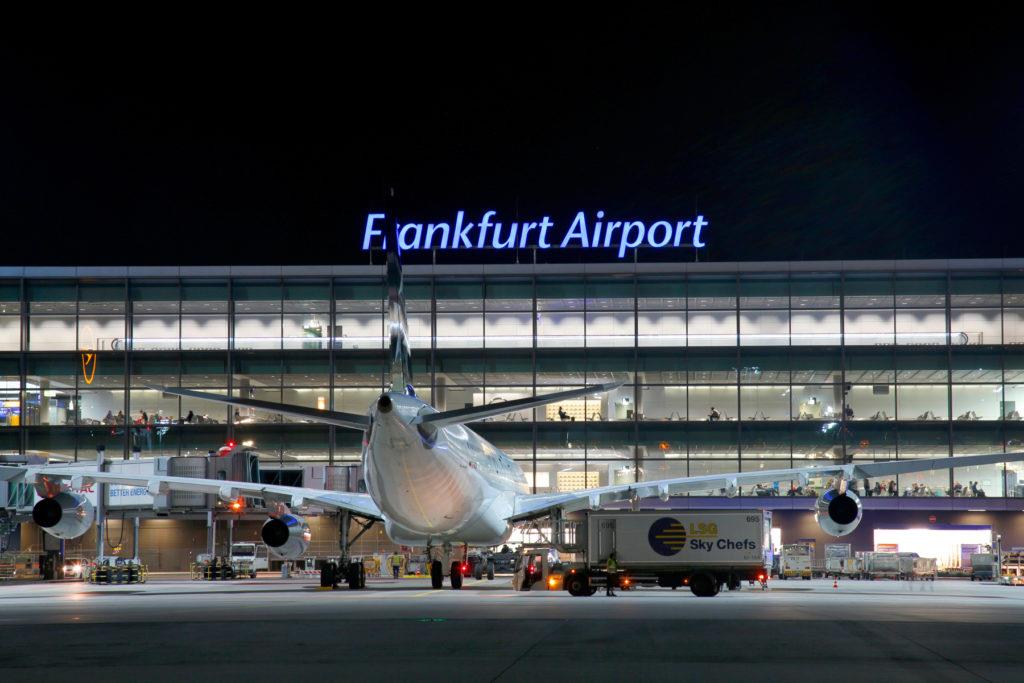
[[562, 510, 772, 597]]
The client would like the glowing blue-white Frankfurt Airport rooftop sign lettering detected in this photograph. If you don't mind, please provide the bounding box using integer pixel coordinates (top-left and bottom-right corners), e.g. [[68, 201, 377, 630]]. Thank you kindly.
[[362, 211, 708, 258]]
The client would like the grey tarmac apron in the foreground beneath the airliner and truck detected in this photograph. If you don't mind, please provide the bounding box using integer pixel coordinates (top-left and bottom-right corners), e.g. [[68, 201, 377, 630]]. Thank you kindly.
[[0, 575, 1024, 683]]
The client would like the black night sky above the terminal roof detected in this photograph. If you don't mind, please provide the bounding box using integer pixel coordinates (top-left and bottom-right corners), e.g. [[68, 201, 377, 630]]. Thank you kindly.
[[0, 11, 1024, 265]]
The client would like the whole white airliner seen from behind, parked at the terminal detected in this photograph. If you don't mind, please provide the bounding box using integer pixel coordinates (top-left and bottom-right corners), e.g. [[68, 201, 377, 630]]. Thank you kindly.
[[0, 246, 1024, 589]]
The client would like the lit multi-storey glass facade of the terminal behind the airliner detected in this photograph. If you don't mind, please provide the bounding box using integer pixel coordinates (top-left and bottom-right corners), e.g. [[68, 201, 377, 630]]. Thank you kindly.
[[6, 262, 1024, 497]]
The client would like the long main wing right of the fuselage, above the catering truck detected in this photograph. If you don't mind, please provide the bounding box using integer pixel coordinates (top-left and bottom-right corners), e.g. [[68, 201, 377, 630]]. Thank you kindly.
[[509, 452, 1024, 521]]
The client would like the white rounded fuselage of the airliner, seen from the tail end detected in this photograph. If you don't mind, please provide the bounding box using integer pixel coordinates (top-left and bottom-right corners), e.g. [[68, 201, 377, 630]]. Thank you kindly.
[[362, 392, 529, 546]]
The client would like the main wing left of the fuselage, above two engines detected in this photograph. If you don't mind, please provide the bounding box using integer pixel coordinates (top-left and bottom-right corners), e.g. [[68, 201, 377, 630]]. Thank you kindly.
[[0, 465, 381, 519]]
